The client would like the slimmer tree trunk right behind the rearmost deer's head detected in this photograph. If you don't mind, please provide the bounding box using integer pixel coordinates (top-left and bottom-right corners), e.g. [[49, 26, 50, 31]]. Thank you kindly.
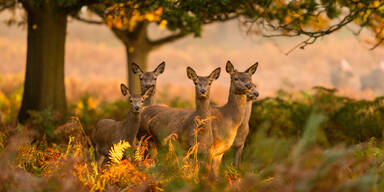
[[125, 44, 150, 94]]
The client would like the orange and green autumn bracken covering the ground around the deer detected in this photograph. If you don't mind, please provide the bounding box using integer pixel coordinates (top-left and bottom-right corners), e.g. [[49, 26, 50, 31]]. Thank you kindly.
[[0, 88, 384, 191]]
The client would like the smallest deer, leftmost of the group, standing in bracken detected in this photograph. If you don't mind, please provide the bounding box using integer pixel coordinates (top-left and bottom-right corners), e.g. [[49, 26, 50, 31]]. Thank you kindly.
[[91, 84, 154, 166]]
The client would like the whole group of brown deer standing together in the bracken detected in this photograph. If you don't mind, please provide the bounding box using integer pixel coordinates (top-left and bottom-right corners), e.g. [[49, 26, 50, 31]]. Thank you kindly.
[[91, 61, 259, 178]]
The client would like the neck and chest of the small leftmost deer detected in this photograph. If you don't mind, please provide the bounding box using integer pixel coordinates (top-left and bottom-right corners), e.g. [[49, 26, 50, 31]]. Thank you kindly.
[[123, 111, 141, 144]]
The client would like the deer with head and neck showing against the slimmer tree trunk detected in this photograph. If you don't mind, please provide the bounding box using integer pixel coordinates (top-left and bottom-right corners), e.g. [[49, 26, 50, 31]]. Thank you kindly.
[[132, 61, 165, 106]]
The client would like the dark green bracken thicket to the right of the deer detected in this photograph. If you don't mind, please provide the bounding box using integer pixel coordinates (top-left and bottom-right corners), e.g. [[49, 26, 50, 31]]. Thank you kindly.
[[250, 87, 384, 144]]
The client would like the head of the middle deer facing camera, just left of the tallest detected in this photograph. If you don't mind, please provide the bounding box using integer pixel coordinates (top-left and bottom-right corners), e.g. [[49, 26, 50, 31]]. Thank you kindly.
[[187, 67, 221, 99]]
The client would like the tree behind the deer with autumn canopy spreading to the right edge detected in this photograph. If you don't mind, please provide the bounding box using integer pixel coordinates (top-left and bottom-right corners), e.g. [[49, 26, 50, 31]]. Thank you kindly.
[[75, 0, 384, 93]]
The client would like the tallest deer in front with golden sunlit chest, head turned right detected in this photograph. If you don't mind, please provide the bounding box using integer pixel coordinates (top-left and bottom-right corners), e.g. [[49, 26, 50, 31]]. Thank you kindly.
[[206, 61, 258, 179]]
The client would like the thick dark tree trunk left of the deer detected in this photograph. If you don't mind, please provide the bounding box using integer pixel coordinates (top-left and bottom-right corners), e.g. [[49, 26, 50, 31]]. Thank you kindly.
[[18, 4, 67, 122]]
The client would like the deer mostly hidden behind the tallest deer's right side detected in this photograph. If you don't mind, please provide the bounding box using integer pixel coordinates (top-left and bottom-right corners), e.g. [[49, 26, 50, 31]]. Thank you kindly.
[[232, 84, 259, 168]]
